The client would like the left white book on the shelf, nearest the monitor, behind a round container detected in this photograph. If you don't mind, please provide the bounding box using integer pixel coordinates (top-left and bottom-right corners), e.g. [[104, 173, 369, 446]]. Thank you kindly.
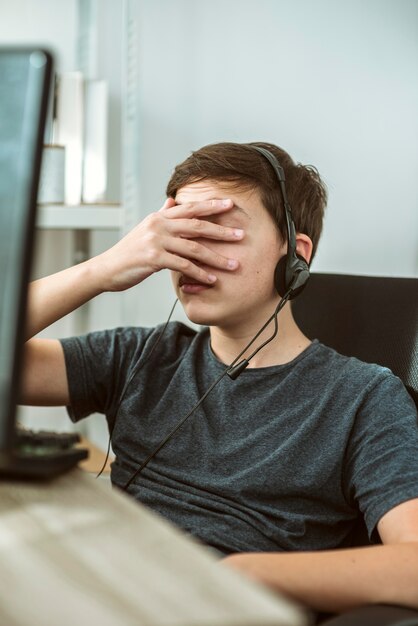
[[54, 72, 84, 204]]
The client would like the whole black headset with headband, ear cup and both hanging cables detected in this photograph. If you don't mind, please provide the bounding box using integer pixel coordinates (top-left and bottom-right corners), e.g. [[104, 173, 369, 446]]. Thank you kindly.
[[98, 144, 309, 491]]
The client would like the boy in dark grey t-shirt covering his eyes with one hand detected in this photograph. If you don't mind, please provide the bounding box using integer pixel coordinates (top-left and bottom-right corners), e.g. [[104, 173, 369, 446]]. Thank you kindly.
[[23, 143, 418, 612]]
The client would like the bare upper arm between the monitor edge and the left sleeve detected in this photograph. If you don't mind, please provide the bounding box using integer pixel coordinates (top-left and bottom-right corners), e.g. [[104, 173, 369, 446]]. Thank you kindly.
[[20, 339, 70, 406]]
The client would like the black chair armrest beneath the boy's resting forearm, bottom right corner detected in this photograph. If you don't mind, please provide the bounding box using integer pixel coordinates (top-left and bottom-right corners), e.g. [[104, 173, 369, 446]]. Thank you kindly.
[[320, 604, 418, 626]]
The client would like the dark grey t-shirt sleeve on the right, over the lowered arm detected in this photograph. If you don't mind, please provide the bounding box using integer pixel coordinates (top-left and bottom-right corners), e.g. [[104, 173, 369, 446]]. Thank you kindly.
[[345, 370, 418, 539]]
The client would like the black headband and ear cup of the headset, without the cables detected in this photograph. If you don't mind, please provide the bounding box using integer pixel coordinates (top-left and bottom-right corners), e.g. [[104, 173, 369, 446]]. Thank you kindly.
[[250, 144, 309, 300]]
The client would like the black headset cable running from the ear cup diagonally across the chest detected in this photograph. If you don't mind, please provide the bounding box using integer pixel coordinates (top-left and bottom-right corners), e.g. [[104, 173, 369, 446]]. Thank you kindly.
[[121, 289, 291, 491]]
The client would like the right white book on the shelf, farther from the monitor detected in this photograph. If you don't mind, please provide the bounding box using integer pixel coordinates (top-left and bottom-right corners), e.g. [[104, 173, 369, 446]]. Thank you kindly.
[[82, 80, 108, 202]]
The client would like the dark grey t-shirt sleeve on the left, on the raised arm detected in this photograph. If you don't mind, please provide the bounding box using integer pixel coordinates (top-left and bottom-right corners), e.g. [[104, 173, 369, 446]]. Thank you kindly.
[[61, 328, 152, 422]]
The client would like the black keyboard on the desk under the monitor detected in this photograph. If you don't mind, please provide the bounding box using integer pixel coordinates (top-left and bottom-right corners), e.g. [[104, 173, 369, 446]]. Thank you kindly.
[[1, 426, 88, 479]]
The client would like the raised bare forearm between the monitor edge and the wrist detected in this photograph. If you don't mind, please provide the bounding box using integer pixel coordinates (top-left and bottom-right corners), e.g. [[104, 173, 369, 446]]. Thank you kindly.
[[26, 259, 103, 339]]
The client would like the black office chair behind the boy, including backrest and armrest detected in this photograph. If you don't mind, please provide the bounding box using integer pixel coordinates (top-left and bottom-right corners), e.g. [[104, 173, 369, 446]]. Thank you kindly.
[[292, 273, 418, 626]]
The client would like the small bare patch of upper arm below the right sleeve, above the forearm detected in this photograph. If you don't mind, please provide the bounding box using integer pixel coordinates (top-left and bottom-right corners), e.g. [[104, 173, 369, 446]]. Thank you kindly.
[[377, 498, 418, 544]]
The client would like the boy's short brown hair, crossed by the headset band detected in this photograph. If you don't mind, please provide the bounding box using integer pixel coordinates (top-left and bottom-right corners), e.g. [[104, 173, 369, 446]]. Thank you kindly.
[[167, 142, 327, 258]]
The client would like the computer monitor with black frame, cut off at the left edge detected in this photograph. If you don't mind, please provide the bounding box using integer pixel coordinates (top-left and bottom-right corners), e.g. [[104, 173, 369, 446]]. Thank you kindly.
[[0, 47, 52, 464]]
